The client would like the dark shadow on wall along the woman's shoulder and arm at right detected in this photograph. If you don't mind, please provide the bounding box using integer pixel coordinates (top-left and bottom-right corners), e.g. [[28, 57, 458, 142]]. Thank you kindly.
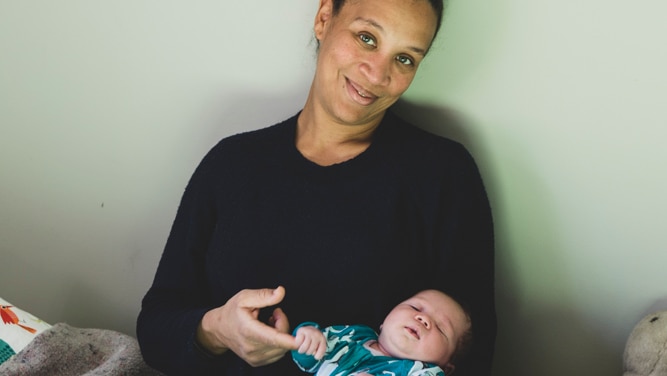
[[395, 100, 622, 376]]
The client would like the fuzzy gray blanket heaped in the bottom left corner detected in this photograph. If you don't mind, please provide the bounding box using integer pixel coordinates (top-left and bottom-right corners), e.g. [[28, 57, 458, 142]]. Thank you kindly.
[[0, 323, 162, 376]]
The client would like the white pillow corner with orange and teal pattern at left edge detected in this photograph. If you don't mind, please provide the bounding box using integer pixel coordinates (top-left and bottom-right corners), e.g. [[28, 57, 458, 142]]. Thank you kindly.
[[0, 298, 51, 364]]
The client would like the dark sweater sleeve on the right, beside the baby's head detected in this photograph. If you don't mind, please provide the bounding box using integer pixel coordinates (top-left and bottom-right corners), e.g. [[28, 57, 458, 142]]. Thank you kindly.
[[436, 145, 496, 376]]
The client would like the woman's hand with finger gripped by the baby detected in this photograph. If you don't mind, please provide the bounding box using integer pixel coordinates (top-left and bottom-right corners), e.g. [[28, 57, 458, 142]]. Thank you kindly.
[[197, 286, 297, 367]]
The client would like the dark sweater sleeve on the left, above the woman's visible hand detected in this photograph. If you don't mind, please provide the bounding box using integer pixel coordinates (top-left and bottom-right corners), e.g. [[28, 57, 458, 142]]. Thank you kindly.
[[137, 145, 227, 375]]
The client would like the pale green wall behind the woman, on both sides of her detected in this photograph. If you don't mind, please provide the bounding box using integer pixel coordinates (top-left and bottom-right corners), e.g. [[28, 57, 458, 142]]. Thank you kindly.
[[0, 0, 667, 376]]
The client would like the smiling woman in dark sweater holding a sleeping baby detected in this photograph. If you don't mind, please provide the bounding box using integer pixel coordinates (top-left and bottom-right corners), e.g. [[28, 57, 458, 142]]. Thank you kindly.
[[137, 0, 495, 375]]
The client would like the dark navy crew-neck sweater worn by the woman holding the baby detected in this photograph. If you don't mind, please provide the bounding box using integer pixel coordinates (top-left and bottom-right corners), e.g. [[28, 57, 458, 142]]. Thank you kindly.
[[137, 112, 496, 376]]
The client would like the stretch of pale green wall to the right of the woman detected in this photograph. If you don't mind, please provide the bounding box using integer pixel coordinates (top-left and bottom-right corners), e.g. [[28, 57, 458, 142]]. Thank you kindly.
[[411, 0, 667, 376]]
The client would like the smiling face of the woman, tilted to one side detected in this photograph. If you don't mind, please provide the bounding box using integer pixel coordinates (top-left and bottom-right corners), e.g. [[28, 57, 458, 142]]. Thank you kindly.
[[312, 0, 437, 125]]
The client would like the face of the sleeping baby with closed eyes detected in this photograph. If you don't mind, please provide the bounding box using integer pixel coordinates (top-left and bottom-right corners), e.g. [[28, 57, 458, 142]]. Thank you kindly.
[[378, 290, 470, 366]]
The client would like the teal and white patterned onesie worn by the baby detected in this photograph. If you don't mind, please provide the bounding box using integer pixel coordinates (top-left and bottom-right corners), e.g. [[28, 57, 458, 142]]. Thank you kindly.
[[292, 322, 445, 376]]
